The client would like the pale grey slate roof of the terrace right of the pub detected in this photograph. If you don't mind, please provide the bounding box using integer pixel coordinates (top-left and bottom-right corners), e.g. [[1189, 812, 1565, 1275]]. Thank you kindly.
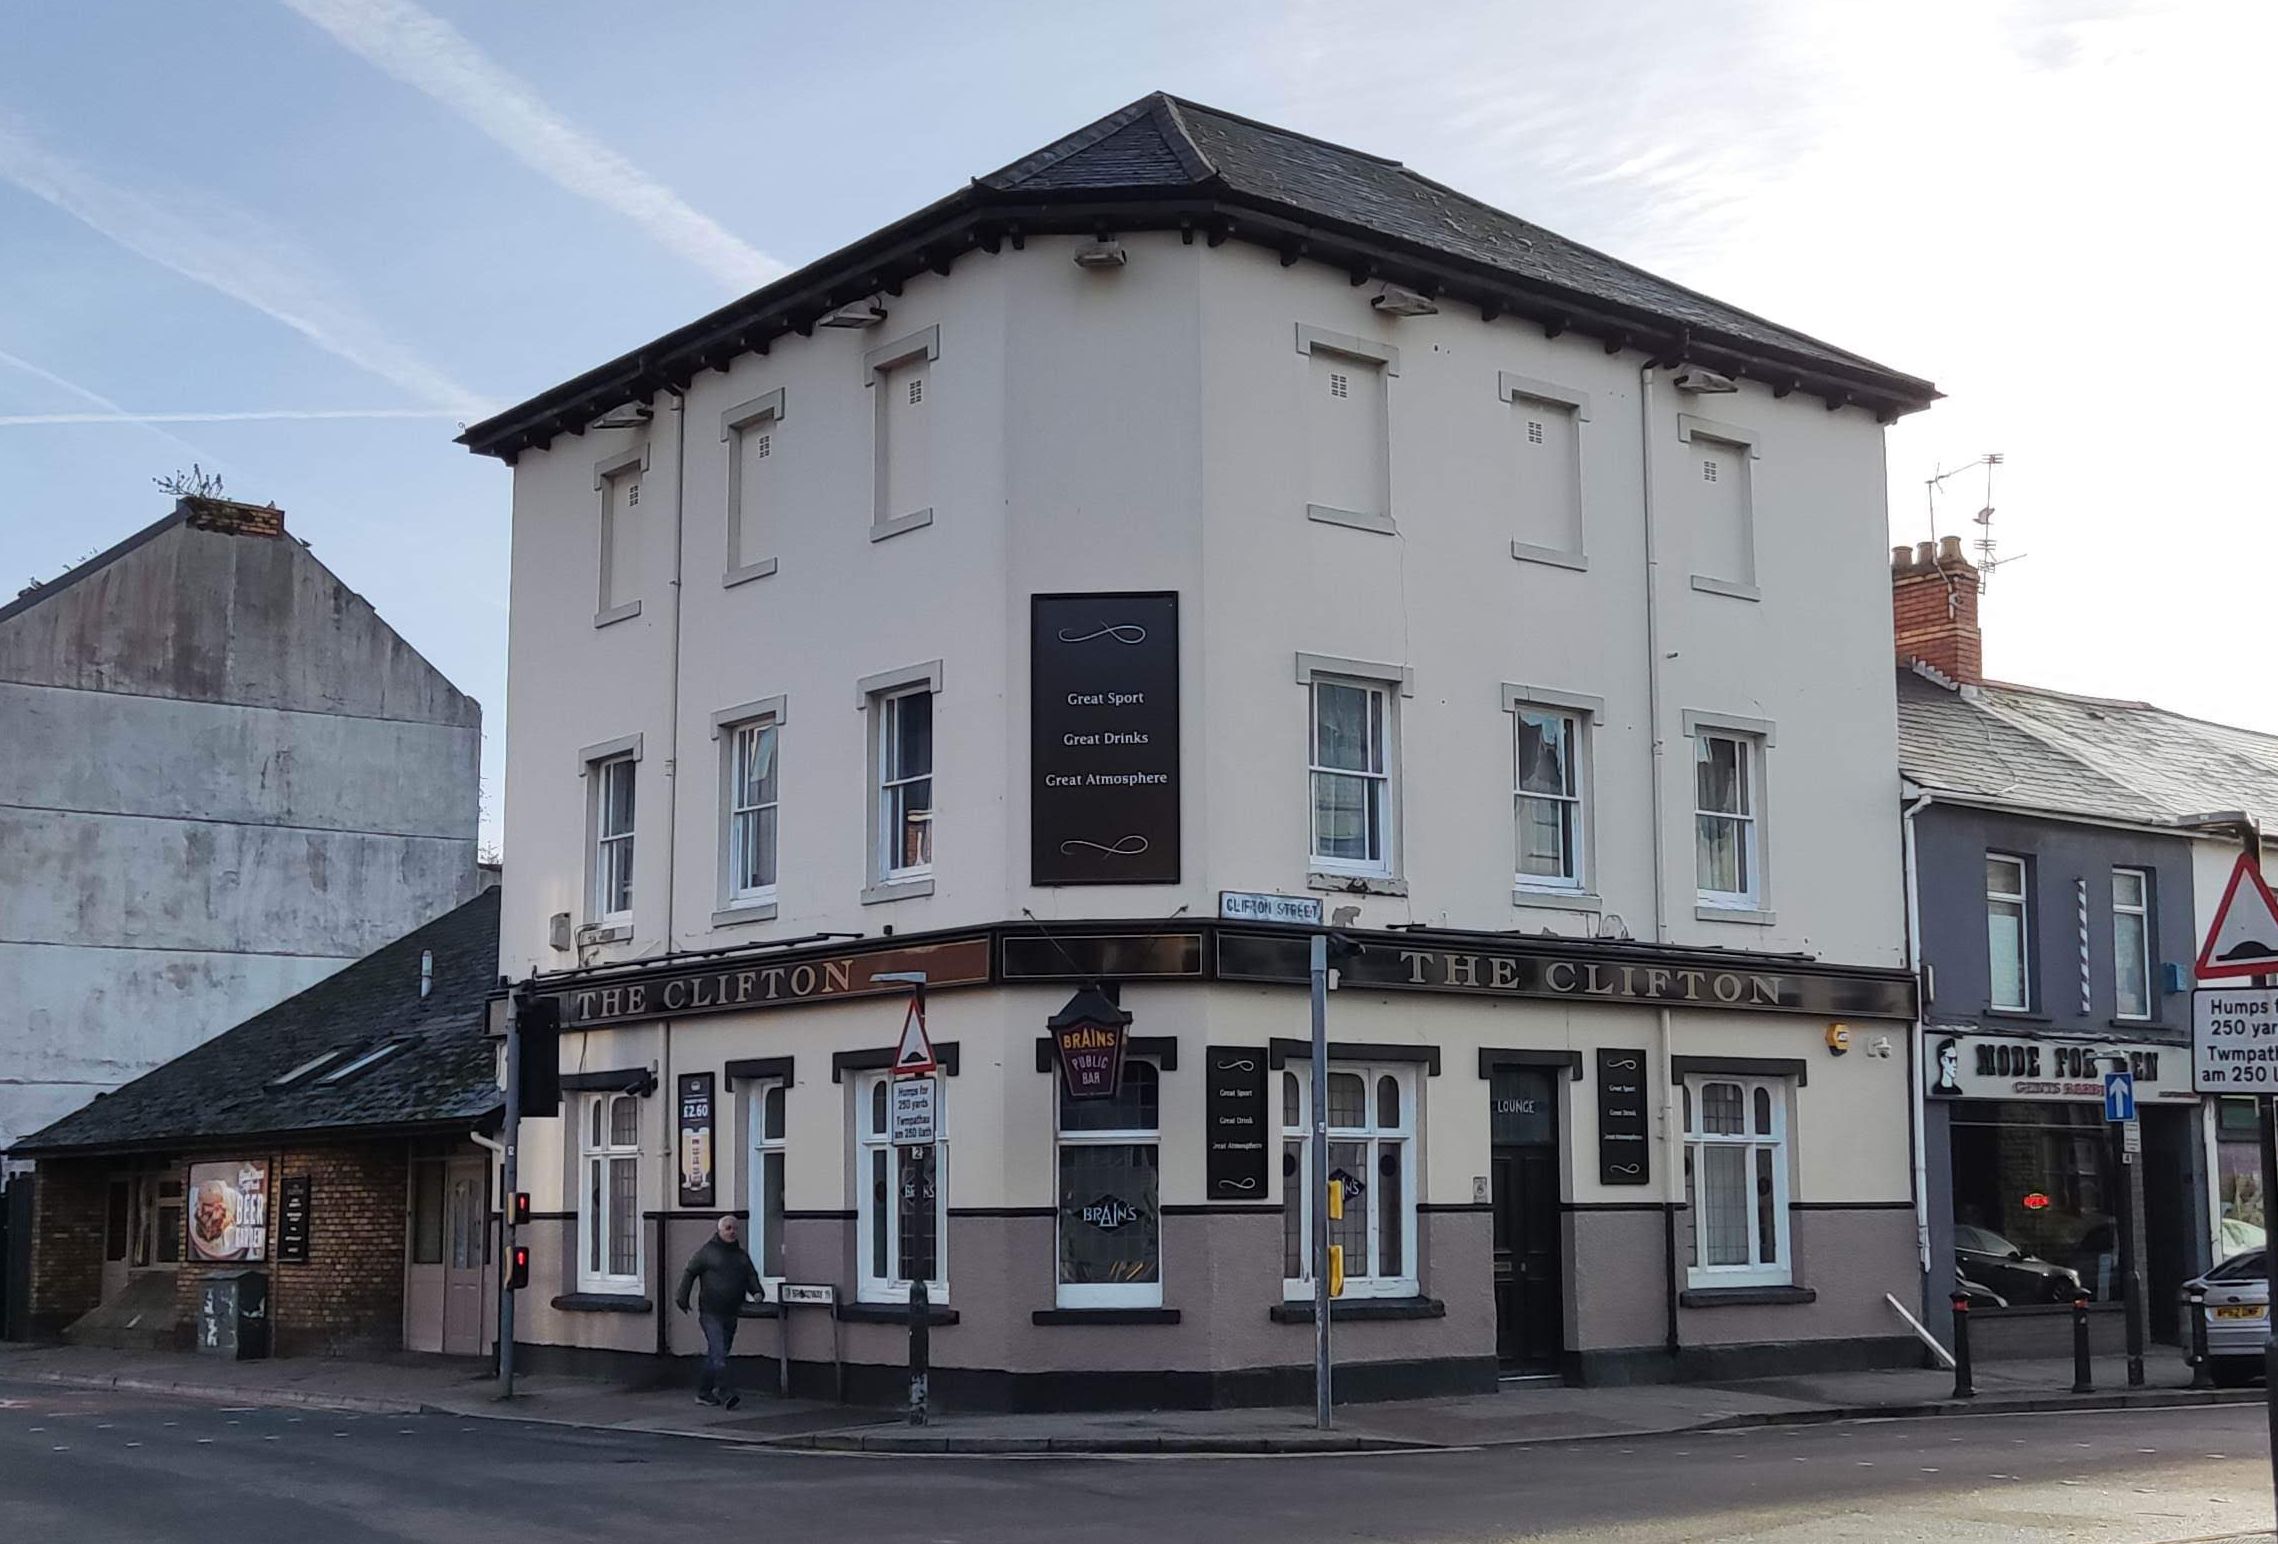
[[1898, 665, 2278, 831]]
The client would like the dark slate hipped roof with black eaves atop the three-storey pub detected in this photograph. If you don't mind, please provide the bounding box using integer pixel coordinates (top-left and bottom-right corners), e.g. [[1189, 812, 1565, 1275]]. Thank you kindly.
[[460, 91, 1939, 460]]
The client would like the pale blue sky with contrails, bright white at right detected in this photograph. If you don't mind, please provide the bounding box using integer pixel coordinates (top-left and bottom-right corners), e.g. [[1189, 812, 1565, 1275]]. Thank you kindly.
[[0, 0, 2278, 840]]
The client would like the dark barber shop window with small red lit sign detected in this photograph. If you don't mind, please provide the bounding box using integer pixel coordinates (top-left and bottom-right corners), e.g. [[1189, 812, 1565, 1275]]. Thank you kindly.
[[1950, 1100, 2125, 1307]]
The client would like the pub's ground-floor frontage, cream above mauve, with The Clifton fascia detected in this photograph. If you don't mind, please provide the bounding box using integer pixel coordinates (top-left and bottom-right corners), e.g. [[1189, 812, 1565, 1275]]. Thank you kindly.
[[519, 922, 1918, 1410]]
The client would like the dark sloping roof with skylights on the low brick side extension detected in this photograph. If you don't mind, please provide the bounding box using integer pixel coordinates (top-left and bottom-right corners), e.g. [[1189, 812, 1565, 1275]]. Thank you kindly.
[[11, 888, 503, 1157]]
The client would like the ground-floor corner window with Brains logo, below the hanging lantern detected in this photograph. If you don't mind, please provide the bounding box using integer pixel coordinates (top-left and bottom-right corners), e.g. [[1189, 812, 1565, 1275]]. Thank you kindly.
[[1057, 1059, 1162, 1307]]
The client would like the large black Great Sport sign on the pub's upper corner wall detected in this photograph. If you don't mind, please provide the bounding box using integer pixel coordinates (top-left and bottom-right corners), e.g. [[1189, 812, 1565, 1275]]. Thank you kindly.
[[1027, 590, 1178, 884]]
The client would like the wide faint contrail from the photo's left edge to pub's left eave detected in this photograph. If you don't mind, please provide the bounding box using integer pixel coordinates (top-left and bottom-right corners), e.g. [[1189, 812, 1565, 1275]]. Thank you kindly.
[[0, 116, 483, 414]]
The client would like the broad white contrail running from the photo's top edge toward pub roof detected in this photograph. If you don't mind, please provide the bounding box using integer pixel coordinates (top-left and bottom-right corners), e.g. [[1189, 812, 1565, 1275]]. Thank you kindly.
[[285, 0, 788, 289]]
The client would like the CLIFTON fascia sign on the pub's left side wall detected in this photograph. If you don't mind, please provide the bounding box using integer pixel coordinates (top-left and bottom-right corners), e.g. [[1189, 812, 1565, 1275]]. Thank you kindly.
[[560, 938, 989, 1029]]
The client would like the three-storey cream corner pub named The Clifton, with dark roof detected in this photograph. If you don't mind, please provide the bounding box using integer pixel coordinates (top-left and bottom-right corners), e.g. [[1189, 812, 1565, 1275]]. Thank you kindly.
[[465, 96, 1934, 1407]]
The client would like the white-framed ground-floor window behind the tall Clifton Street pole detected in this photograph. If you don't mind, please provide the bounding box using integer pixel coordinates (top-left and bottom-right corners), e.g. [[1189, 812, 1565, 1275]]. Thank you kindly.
[[1283, 1061, 1417, 1298]]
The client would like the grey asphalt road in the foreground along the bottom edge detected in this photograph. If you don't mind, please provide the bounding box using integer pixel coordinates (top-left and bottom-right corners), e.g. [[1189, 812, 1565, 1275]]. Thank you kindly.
[[0, 1382, 2271, 1544]]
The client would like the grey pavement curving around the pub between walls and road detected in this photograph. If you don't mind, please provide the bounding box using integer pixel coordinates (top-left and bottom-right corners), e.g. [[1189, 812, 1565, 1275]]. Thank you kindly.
[[0, 1346, 2262, 1455]]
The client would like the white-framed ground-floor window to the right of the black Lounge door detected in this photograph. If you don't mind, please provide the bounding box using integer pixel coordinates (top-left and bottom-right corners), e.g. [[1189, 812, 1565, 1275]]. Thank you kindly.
[[1683, 1075, 1795, 1287]]
